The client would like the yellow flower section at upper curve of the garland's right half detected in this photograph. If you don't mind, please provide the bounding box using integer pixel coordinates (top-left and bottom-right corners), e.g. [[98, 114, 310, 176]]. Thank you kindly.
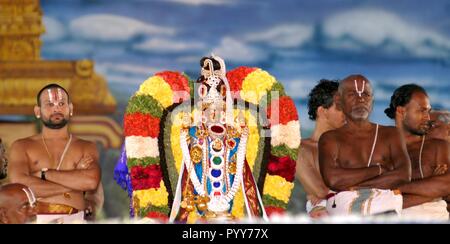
[[241, 69, 277, 104]]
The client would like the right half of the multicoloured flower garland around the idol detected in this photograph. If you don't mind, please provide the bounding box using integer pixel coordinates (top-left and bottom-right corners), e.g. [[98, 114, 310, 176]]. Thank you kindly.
[[227, 67, 301, 216]]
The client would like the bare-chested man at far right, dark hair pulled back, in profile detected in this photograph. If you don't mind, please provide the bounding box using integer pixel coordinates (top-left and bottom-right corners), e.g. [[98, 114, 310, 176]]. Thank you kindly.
[[385, 84, 450, 220]]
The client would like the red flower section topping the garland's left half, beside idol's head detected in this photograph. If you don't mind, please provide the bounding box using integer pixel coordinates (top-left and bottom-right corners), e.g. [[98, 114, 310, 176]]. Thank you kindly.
[[155, 71, 190, 103]]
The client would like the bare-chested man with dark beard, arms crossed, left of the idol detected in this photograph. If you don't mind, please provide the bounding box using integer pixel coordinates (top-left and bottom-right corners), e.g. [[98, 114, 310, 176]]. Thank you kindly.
[[9, 84, 100, 223]]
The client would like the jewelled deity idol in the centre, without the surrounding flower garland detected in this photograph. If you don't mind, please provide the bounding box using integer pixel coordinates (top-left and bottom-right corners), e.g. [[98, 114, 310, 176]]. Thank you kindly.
[[171, 56, 266, 221]]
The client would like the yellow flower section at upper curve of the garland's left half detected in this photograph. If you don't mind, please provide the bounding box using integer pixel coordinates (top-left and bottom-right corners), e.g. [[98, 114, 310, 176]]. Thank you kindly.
[[136, 76, 173, 108]]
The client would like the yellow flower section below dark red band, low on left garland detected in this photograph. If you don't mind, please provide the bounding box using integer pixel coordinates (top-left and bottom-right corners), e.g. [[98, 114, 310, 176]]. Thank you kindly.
[[133, 181, 169, 208]]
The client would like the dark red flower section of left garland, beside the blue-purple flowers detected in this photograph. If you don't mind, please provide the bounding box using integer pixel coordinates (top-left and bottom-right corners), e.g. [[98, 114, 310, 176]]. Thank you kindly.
[[131, 165, 162, 190]]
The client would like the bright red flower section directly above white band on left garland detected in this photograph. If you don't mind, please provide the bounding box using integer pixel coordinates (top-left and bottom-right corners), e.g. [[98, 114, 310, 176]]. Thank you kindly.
[[124, 113, 160, 138]]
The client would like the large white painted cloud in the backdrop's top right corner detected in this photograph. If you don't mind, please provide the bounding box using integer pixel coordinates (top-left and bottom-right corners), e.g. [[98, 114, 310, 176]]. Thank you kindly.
[[323, 9, 450, 58]]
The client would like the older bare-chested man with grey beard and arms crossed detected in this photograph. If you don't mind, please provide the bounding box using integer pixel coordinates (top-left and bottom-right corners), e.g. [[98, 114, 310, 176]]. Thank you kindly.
[[319, 75, 411, 216]]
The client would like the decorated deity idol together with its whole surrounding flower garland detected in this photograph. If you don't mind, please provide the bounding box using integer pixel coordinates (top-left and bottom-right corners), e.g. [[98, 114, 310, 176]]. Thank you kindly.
[[114, 55, 300, 223]]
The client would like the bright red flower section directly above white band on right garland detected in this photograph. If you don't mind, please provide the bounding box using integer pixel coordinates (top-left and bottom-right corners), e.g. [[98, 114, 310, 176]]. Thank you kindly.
[[267, 96, 298, 125]]
